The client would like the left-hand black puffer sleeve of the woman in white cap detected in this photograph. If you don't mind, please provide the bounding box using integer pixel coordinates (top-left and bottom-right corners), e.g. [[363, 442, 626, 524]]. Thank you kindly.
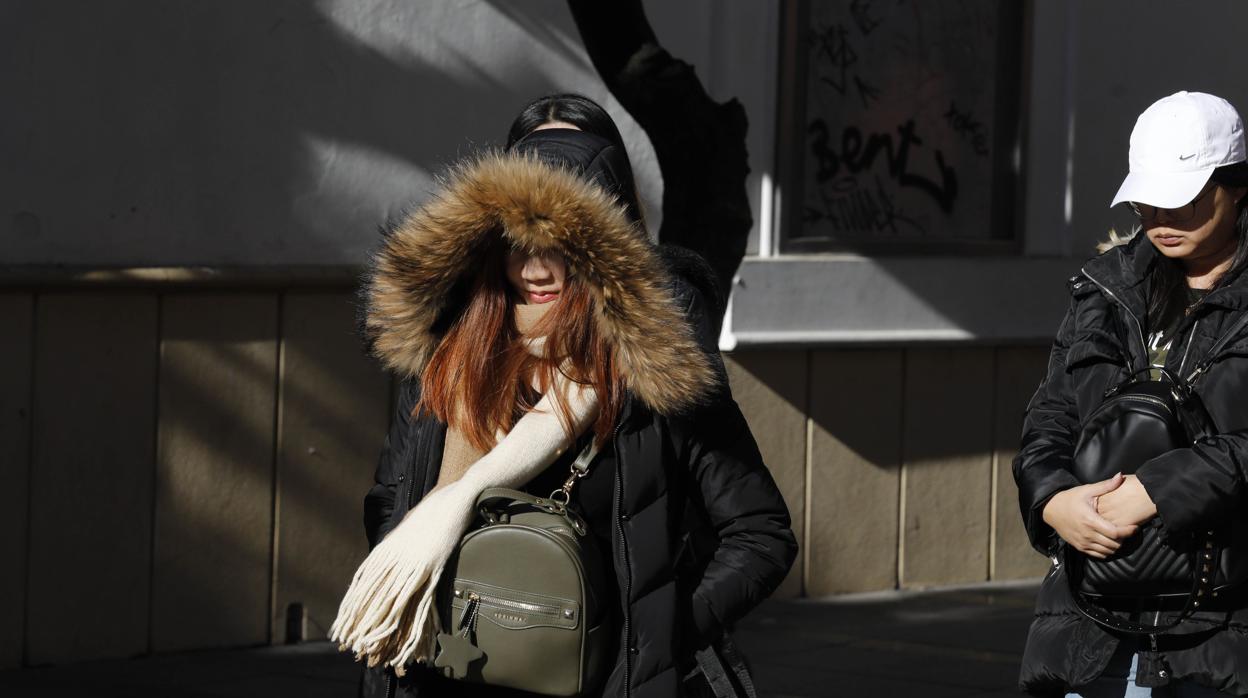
[[1013, 300, 1081, 556]]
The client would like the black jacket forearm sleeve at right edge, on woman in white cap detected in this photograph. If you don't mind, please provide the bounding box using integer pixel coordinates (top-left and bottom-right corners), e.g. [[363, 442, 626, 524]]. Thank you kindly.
[[1136, 430, 1248, 533]]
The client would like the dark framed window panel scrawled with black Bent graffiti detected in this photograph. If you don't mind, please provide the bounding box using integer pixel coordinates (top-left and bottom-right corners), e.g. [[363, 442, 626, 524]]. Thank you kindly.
[[800, 0, 1001, 245]]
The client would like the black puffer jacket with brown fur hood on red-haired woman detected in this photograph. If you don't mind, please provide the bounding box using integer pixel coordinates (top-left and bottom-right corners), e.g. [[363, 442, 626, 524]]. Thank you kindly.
[[356, 132, 796, 698]]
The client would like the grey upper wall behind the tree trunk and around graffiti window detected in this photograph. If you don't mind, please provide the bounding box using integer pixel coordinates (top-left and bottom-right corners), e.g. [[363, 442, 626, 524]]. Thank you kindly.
[[21, 0, 1248, 277]]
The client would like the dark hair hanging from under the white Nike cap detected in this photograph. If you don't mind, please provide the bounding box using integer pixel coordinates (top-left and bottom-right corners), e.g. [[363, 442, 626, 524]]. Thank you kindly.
[[1148, 162, 1248, 331]]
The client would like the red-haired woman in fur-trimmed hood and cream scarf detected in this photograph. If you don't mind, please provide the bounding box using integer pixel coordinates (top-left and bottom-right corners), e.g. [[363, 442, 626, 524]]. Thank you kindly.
[[331, 96, 796, 698]]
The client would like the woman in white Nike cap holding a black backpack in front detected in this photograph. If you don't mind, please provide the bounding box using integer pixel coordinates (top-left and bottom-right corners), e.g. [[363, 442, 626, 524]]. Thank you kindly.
[[1013, 92, 1248, 697]]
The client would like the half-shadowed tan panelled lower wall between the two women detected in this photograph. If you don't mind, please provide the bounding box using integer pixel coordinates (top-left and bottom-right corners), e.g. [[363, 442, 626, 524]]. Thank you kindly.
[[730, 346, 1048, 597]]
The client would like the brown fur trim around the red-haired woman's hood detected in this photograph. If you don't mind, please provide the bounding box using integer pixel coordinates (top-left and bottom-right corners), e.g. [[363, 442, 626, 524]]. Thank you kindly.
[[364, 152, 716, 415]]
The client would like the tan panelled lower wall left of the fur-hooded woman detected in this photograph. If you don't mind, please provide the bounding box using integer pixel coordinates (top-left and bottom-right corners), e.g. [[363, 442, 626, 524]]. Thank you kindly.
[[17, 291, 391, 664]]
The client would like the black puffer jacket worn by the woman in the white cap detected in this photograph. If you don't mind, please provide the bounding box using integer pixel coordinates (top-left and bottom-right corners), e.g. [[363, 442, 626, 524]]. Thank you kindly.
[[1013, 235, 1248, 696]]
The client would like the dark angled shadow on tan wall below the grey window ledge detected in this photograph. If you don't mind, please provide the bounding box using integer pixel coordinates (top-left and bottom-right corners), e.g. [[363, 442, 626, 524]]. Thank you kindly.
[[730, 345, 1048, 467]]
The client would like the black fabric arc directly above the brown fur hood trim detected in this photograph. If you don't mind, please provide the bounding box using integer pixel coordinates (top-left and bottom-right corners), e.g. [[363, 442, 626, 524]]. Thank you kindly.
[[510, 129, 641, 221]]
